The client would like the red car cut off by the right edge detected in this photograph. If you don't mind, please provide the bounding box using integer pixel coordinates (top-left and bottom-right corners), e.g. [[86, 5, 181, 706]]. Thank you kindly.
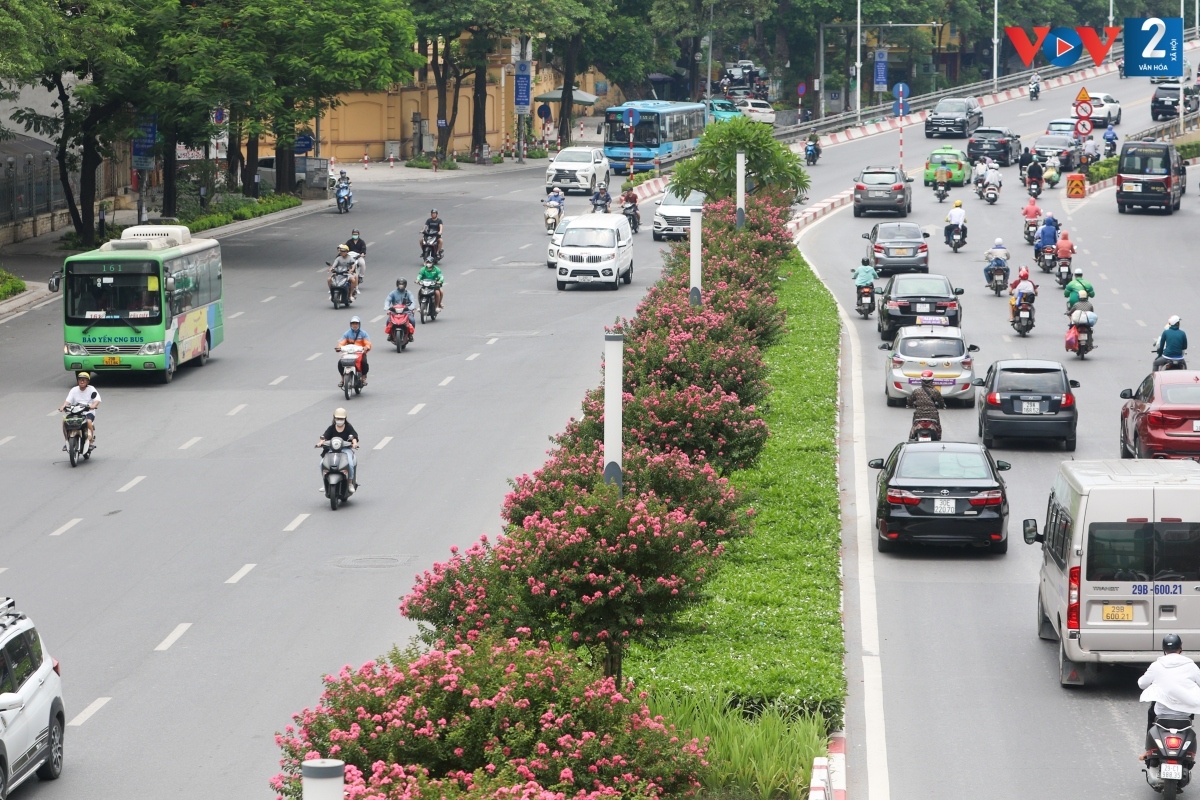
[[1121, 369, 1200, 459]]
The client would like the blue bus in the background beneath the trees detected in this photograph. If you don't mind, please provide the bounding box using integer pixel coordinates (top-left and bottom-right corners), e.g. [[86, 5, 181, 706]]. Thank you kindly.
[[604, 100, 704, 175]]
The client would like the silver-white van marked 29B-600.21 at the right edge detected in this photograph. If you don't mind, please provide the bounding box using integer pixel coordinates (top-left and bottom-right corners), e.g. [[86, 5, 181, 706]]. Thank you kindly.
[[1024, 458, 1200, 686]]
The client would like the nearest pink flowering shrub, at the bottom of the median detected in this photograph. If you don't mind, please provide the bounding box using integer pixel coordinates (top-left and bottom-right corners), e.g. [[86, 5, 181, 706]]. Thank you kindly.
[[271, 637, 703, 800]]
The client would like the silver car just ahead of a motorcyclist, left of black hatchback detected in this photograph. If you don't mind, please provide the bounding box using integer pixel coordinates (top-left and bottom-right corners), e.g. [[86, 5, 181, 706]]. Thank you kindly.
[[880, 325, 979, 408]]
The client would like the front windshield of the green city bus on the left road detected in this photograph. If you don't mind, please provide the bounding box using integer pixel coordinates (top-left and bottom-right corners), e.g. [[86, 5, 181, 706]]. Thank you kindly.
[[64, 261, 162, 326]]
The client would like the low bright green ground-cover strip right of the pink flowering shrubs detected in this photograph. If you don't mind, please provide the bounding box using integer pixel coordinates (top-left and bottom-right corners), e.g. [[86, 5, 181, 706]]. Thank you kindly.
[[625, 248, 846, 729]]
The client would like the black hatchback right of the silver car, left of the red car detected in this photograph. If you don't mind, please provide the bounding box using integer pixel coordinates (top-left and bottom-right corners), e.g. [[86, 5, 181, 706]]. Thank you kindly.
[[974, 359, 1079, 451]]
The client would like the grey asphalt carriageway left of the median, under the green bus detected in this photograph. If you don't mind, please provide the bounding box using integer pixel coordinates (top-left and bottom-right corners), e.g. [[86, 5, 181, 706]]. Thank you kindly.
[[0, 167, 660, 800]]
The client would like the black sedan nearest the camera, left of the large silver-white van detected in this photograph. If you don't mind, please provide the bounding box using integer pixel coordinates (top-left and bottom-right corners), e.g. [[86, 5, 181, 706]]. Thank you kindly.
[[866, 441, 1009, 553]]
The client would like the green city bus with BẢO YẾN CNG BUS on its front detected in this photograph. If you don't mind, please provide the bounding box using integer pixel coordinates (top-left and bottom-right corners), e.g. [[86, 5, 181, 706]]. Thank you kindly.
[[50, 225, 224, 384]]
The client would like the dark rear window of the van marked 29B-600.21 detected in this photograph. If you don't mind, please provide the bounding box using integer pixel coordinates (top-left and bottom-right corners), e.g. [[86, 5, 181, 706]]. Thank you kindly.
[[1087, 522, 1200, 581]]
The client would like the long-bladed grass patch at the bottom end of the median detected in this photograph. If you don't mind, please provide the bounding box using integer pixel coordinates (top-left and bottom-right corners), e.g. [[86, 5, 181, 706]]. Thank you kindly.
[[650, 692, 828, 800]]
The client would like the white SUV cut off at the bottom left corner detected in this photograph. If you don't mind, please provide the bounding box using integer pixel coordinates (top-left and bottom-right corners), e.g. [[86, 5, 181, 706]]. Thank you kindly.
[[0, 597, 65, 798]]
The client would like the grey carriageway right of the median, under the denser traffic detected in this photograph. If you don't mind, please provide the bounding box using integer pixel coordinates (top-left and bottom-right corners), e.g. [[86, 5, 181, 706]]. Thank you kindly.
[[800, 77, 1200, 800]]
